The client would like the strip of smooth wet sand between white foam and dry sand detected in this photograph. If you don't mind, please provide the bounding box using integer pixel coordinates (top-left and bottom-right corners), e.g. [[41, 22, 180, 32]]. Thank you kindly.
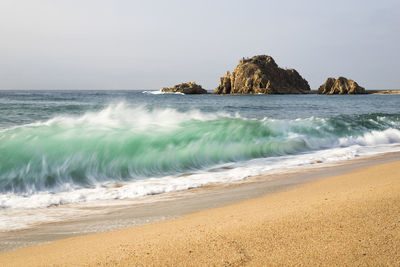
[[0, 152, 400, 255]]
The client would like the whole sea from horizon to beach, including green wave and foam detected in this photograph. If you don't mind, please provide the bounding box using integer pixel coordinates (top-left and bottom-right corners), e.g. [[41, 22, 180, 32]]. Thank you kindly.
[[0, 90, 400, 231]]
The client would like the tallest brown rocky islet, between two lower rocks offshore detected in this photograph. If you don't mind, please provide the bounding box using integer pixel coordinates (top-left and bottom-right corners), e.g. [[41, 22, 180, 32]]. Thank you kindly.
[[214, 55, 310, 94]]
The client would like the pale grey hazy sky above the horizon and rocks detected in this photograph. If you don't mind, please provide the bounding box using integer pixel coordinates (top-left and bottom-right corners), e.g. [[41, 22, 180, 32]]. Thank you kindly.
[[0, 0, 400, 89]]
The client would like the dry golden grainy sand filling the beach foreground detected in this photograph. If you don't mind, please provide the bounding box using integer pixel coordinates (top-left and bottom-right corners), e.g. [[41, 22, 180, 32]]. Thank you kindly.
[[0, 161, 400, 266]]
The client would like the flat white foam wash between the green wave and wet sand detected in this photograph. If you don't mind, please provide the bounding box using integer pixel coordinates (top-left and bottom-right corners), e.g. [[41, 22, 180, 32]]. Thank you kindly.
[[0, 142, 400, 231]]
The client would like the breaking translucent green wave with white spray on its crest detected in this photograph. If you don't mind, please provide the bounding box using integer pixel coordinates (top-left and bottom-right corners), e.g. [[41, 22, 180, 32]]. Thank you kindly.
[[0, 103, 400, 196]]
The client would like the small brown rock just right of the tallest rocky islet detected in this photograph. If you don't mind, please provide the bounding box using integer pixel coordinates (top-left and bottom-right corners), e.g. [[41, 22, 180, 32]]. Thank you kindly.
[[318, 77, 366, 95]]
